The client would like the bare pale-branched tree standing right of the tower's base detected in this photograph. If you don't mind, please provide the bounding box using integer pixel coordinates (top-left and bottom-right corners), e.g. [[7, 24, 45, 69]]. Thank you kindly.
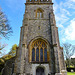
[[63, 43, 75, 67]]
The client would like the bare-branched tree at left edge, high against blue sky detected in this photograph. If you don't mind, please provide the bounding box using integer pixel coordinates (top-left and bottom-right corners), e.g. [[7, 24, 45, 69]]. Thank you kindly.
[[0, 8, 12, 37]]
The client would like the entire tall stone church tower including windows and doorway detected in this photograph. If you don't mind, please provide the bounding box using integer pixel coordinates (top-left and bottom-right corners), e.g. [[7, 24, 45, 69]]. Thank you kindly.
[[13, 0, 67, 75]]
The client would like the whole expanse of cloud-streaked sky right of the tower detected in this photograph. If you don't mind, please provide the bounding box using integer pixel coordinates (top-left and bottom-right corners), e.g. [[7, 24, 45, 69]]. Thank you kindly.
[[53, 0, 75, 42]]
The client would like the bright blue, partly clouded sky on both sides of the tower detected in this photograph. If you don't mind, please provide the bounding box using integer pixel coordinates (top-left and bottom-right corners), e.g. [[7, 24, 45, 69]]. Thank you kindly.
[[0, 0, 75, 57]]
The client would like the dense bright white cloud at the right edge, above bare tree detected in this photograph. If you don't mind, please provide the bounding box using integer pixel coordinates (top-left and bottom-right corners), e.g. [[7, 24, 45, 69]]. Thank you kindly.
[[60, 18, 75, 42]]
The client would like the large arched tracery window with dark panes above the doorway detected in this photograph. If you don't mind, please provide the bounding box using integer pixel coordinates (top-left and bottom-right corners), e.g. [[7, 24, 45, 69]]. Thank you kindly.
[[30, 39, 48, 62]]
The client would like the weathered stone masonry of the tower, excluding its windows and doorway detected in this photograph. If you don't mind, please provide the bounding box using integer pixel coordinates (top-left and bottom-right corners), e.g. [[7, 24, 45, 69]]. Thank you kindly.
[[12, 0, 65, 75]]
